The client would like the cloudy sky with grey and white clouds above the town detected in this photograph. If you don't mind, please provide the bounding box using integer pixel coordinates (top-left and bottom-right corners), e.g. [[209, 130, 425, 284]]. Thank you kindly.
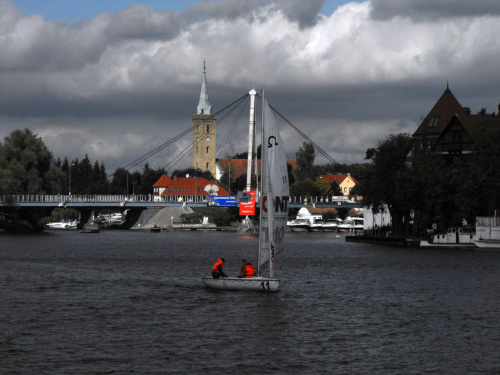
[[0, 0, 500, 176]]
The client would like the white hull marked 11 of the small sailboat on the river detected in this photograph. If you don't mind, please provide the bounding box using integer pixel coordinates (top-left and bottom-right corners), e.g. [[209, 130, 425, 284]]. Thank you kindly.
[[202, 277, 280, 292]]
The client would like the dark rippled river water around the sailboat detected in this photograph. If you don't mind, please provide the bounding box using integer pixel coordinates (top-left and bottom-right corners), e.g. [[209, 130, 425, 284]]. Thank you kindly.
[[0, 230, 500, 375]]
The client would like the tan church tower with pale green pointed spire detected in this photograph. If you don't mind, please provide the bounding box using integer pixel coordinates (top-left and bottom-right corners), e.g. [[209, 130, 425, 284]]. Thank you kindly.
[[192, 62, 217, 177]]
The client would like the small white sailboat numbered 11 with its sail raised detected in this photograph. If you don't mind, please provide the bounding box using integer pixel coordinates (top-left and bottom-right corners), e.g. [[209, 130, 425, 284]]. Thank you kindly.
[[202, 90, 290, 292]]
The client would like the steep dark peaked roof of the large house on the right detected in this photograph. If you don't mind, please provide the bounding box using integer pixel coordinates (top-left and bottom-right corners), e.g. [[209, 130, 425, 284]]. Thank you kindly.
[[413, 87, 470, 137]]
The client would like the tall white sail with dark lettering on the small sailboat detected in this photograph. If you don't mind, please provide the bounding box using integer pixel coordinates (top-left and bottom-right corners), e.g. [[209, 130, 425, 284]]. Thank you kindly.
[[259, 100, 290, 277]]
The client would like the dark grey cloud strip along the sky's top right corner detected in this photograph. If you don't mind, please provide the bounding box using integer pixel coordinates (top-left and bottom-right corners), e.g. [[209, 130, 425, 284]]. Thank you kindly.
[[372, 0, 500, 21]]
